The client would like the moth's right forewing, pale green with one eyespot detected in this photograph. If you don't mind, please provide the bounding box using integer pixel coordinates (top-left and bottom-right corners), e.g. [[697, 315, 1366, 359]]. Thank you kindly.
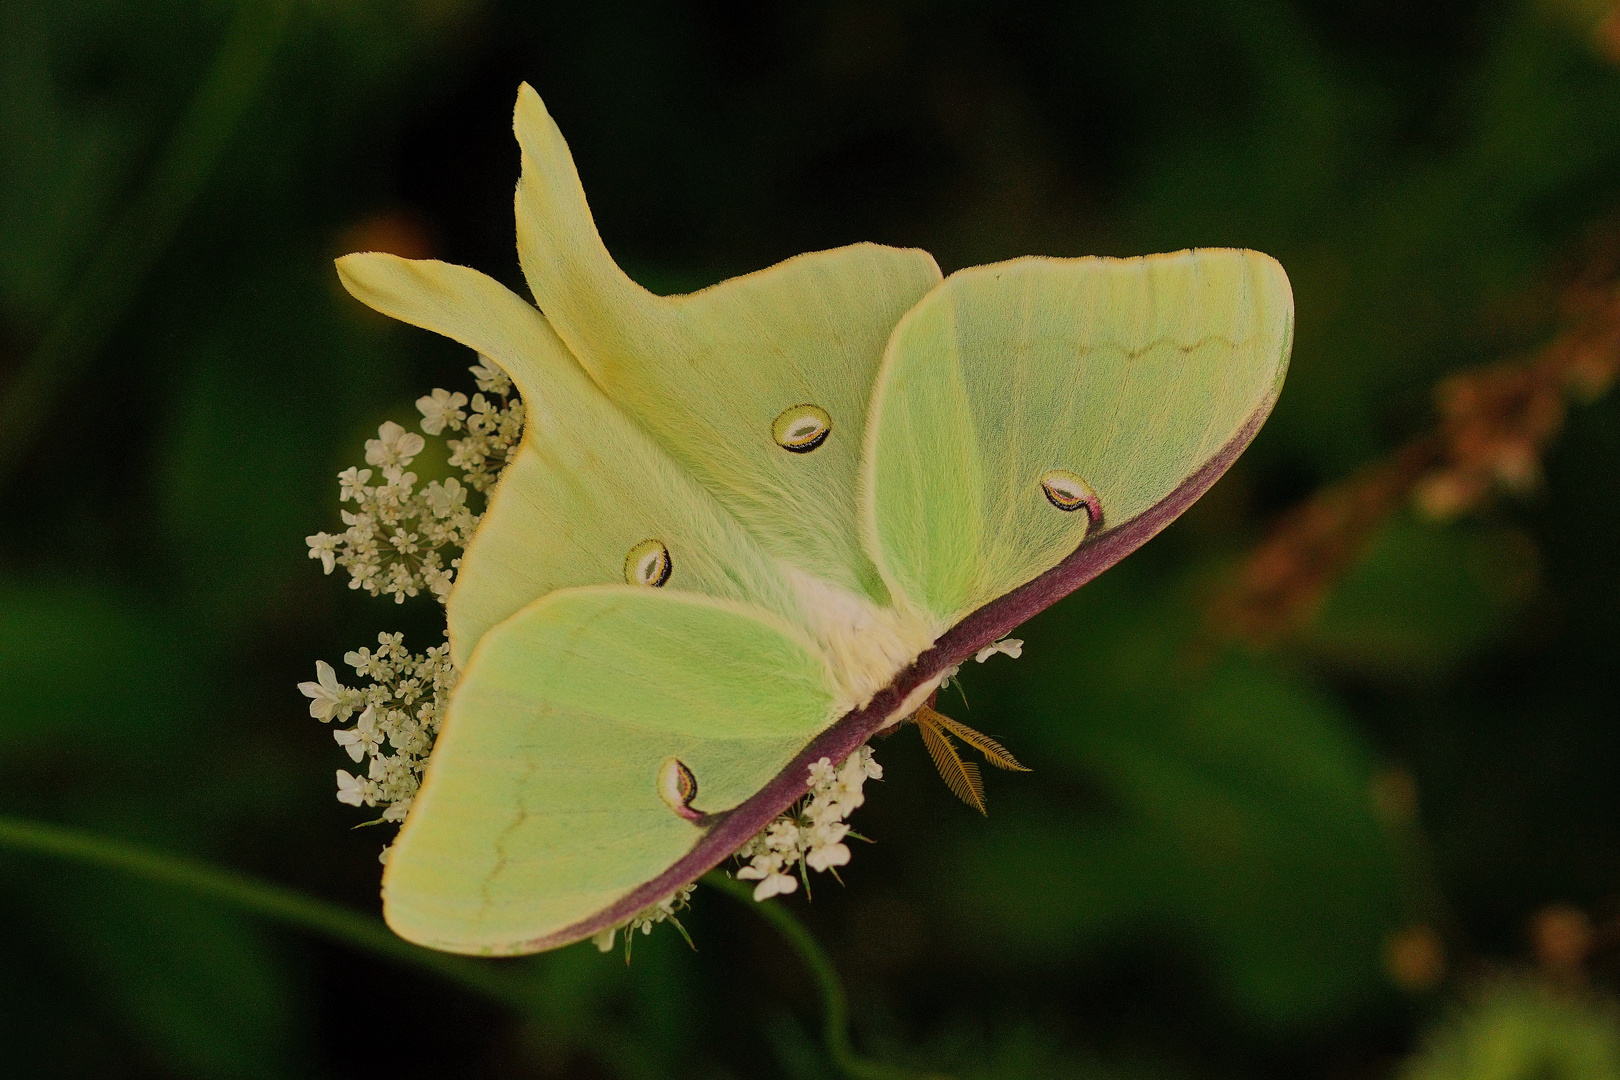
[[863, 249, 1293, 628]]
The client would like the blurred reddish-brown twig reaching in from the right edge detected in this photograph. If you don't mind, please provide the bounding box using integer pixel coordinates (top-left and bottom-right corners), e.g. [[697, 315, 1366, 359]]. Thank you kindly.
[[1209, 233, 1620, 646]]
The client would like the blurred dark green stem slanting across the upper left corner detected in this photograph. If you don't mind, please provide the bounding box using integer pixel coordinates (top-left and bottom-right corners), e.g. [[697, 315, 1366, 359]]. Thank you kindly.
[[0, 0, 292, 481]]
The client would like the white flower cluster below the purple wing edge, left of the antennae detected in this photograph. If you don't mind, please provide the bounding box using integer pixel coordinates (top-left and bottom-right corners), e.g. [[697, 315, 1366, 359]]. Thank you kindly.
[[737, 746, 883, 900]]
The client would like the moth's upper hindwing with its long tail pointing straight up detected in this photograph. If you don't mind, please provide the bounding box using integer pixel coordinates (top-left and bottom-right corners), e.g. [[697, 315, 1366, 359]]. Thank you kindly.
[[514, 84, 940, 604]]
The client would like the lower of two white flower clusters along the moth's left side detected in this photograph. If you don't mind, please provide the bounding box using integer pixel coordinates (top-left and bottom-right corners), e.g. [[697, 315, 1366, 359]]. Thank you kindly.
[[298, 633, 457, 821]]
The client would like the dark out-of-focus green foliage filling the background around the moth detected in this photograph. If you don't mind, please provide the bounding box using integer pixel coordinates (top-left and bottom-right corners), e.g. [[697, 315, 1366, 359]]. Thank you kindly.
[[0, 0, 1620, 1080]]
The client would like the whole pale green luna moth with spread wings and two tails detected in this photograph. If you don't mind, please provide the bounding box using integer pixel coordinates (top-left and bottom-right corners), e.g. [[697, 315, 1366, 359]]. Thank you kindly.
[[328, 86, 1293, 954]]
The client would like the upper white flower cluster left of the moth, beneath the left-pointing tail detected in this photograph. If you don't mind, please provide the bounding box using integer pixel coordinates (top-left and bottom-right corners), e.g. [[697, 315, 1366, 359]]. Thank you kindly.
[[305, 356, 523, 604]]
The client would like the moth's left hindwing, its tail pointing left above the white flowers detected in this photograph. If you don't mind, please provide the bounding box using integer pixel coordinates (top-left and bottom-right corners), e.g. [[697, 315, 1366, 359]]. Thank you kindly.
[[337, 254, 799, 665]]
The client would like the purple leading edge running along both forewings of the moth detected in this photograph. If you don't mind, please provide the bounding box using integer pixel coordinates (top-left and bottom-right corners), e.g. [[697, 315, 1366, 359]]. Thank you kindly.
[[512, 393, 1277, 954]]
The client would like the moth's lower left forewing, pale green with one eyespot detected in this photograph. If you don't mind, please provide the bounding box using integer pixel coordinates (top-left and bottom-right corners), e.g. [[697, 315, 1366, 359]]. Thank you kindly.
[[382, 586, 841, 954]]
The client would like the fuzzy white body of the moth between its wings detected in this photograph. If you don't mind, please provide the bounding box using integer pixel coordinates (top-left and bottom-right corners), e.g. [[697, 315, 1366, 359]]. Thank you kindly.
[[781, 562, 933, 709]]
